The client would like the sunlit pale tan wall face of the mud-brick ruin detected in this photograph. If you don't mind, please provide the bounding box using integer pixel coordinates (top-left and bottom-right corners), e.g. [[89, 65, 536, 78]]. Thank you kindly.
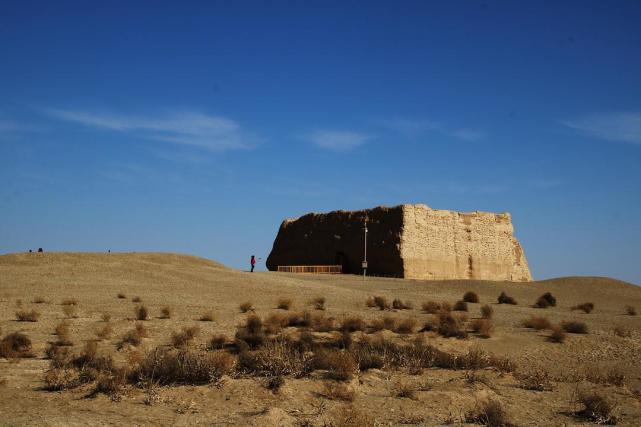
[[401, 205, 532, 281]]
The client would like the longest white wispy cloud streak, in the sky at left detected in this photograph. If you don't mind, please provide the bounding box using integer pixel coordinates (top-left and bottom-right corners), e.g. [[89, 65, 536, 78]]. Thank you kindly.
[[44, 108, 259, 151]]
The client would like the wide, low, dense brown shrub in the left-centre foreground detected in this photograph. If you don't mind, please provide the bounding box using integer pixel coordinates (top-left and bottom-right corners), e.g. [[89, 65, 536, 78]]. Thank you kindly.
[[130, 348, 235, 385]]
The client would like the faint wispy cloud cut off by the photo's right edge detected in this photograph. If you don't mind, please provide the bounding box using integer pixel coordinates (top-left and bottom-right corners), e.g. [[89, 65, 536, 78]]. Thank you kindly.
[[561, 112, 641, 144]]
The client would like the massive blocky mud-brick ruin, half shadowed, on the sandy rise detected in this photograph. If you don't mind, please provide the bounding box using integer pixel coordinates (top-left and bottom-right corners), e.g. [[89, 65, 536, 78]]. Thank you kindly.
[[267, 205, 532, 281]]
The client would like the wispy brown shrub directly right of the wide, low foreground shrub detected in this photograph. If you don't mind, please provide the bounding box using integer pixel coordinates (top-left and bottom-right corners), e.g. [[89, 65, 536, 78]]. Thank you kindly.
[[238, 339, 311, 377]]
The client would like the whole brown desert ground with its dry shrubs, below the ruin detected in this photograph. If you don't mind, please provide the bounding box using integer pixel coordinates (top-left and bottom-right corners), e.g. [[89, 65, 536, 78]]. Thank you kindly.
[[0, 253, 641, 426]]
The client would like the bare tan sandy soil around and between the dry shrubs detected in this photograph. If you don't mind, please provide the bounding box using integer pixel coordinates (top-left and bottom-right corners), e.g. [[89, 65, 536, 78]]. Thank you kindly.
[[0, 253, 641, 426]]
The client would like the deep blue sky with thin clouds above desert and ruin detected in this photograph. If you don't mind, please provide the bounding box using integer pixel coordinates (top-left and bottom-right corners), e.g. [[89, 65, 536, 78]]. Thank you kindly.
[[0, 1, 641, 283]]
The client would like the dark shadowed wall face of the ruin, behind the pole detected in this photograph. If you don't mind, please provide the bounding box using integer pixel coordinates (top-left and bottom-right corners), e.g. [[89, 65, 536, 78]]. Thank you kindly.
[[267, 206, 403, 277]]
